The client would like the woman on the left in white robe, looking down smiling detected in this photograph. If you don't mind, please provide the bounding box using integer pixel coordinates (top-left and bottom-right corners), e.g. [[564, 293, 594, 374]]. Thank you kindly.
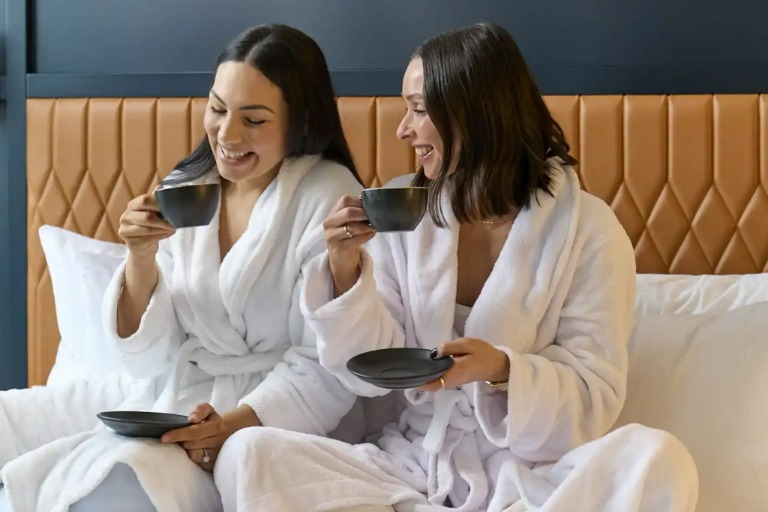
[[0, 25, 362, 512]]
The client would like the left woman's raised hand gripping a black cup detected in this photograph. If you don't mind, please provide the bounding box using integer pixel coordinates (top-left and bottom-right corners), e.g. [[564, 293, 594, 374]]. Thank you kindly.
[[117, 194, 174, 260]]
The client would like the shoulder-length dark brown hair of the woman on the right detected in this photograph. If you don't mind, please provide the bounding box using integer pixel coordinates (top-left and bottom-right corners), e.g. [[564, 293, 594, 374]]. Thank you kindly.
[[413, 23, 576, 226]]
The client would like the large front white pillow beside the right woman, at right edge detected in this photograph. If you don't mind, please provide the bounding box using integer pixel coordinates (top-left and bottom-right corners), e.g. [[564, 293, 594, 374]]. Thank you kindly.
[[616, 303, 768, 512]]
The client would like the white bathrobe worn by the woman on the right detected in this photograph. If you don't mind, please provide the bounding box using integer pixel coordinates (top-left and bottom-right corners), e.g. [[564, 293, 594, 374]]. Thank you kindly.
[[216, 162, 697, 512]]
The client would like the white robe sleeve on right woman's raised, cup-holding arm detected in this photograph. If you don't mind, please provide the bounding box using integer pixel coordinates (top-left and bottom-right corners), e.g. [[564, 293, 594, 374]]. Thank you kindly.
[[302, 234, 406, 397]]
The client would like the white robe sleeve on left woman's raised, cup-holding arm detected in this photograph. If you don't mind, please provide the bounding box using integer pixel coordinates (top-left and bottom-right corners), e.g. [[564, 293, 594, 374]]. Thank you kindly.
[[102, 240, 184, 378]]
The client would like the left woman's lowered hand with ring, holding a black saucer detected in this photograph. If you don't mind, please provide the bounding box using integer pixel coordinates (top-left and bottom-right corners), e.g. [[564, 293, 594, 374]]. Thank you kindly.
[[161, 403, 261, 471]]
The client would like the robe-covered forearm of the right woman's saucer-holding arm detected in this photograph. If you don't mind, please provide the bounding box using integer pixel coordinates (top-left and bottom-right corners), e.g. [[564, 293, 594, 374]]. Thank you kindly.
[[474, 345, 622, 462]]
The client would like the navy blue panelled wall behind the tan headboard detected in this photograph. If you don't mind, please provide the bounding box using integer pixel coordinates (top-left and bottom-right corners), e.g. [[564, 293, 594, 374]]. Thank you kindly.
[[0, 0, 768, 388]]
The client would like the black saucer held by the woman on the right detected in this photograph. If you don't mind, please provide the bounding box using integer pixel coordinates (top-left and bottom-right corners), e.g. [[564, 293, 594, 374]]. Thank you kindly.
[[347, 348, 453, 389]]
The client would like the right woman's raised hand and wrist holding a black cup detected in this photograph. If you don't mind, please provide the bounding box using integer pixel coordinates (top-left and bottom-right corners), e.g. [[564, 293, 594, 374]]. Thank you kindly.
[[323, 196, 376, 296]]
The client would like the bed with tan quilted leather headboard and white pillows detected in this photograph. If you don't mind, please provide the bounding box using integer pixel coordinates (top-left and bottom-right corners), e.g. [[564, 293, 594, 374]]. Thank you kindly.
[[27, 94, 768, 512]]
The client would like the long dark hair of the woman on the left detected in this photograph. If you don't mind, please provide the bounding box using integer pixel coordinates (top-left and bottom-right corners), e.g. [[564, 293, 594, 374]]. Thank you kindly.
[[163, 24, 362, 184]]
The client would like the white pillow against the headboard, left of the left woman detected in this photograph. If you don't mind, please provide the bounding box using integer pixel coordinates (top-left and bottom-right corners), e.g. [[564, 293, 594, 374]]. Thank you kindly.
[[38, 225, 128, 385]]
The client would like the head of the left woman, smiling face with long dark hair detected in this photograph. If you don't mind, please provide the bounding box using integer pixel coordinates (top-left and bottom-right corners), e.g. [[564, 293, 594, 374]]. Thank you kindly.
[[163, 26, 355, 189]]
